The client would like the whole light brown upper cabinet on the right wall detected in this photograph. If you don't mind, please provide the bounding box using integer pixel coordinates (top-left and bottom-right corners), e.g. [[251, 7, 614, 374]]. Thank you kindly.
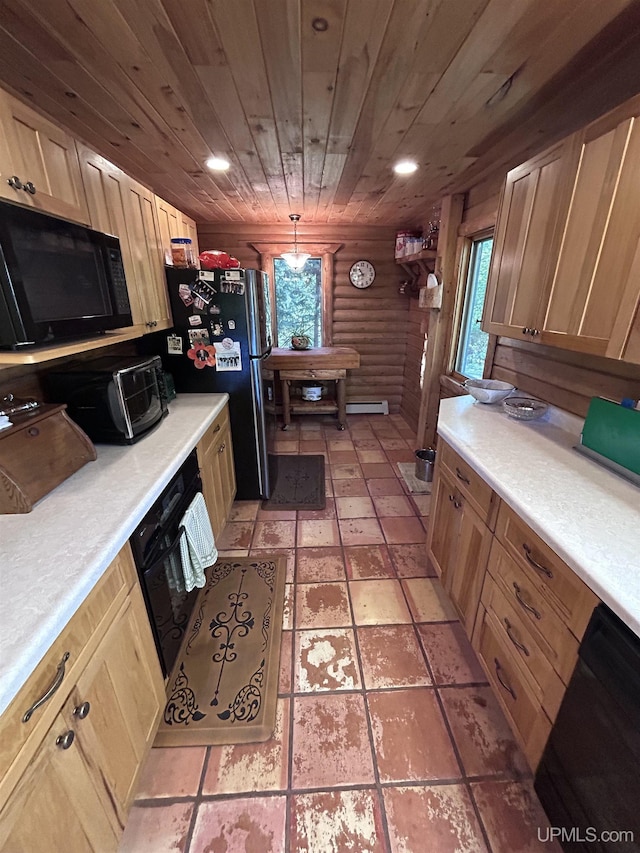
[[483, 97, 640, 363]]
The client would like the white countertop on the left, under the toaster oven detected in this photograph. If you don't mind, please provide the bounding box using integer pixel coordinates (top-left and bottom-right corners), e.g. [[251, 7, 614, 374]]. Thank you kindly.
[[0, 394, 228, 714]]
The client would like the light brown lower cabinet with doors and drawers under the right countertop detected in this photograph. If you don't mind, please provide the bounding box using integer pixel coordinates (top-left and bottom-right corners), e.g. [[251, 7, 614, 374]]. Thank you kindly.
[[427, 440, 598, 770]]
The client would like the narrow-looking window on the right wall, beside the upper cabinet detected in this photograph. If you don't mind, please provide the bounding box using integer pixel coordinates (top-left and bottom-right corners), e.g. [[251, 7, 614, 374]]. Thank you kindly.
[[455, 237, 493, 379]]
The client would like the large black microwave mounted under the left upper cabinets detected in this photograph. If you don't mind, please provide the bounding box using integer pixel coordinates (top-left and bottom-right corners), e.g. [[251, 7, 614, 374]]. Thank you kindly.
[[0, 202, 133, 350]]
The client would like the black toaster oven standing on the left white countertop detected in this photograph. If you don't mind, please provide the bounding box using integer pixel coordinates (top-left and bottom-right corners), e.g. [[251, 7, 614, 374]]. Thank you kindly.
[[42, 355, 169, 444]]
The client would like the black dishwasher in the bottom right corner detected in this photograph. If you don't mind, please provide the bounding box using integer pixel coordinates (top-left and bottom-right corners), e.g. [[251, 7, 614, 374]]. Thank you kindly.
[[535, 604, 640, 853]]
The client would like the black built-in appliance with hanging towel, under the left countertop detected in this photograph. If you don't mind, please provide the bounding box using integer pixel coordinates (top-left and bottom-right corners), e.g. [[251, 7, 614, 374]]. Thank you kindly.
[[129, 450, 202, 675]]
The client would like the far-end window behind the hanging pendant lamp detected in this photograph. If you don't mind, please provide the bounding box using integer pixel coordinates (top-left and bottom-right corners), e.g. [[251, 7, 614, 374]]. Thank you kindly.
[[273, 257, 322, 347]]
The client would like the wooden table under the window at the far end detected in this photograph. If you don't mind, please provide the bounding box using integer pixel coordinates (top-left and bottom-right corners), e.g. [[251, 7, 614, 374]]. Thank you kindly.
[[263, 347, 360, 430]]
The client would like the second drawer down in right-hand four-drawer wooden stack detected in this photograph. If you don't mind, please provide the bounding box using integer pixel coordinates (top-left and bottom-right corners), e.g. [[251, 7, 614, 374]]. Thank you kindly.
[[487, 539, 578, 684]]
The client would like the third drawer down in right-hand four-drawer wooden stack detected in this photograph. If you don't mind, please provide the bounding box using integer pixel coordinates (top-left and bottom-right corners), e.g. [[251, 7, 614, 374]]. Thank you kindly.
[[482, 574, 565, 722]]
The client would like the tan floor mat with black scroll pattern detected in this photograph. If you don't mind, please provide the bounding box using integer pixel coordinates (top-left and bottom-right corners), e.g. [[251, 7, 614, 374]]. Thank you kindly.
[[155, 557, 286, 746]]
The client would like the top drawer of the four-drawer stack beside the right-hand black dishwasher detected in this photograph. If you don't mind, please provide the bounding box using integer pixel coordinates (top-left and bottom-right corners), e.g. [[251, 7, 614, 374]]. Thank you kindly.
[[496, 503, 599, 640]]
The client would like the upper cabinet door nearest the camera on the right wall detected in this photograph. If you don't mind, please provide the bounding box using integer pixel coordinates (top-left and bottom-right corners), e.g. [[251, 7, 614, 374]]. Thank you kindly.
[[542, 111, 640, 358]]
